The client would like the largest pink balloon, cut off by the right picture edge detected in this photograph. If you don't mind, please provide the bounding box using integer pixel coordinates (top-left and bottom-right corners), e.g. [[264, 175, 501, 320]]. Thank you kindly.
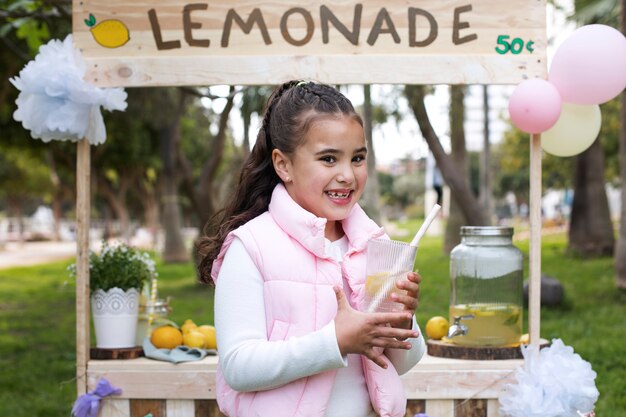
[[548, 25, 626, 104]]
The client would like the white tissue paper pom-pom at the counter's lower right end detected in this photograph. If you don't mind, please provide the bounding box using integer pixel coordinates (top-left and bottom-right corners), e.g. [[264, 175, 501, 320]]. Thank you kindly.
[[500, 339, 599, 417]]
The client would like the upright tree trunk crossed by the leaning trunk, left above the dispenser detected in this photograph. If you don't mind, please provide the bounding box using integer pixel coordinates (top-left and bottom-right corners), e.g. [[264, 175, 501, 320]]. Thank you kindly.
[[443, 85, 469, 253]]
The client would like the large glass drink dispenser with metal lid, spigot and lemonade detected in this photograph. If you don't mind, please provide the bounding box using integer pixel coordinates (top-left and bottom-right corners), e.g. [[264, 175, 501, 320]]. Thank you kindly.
[[448, 226, 524, 346]]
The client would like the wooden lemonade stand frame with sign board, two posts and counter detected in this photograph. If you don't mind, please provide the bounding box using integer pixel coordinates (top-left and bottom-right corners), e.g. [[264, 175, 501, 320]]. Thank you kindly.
[[73, 0, 547, 417]]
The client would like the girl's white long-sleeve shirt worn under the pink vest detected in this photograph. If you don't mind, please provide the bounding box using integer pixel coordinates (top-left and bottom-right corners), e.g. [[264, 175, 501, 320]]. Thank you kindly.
[[215, 237, 426, 417]]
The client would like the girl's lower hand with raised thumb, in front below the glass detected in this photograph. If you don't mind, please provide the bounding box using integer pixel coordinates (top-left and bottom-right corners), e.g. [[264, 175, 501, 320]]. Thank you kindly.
[[333, 286, 419, 368]]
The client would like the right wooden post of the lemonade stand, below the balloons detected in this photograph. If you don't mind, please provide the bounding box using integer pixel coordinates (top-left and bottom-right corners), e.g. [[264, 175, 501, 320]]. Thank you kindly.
[[528, 134, 541, 346]]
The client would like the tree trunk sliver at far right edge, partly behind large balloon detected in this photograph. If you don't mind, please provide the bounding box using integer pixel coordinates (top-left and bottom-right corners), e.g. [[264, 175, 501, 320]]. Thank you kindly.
[[614, 0, 626, 289]]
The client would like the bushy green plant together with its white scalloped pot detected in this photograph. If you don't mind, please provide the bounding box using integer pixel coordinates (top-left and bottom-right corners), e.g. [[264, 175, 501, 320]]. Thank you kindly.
[[72, 242, 157, 349]]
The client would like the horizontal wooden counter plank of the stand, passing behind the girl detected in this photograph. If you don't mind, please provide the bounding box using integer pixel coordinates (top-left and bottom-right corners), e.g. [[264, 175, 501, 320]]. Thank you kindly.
[[88, 355, 523, 400]]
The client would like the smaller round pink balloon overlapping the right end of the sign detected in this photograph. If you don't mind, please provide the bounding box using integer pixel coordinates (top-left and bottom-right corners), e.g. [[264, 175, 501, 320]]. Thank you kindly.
[[509, 78, 562, 133]]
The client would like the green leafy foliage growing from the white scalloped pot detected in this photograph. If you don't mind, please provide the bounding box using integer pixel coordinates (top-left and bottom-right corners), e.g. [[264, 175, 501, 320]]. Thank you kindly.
[[69, 241, 157, 293]]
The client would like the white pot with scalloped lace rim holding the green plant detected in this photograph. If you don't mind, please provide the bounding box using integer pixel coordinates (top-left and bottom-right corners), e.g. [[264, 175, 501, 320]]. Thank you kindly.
[[91, 288, 139, 349]]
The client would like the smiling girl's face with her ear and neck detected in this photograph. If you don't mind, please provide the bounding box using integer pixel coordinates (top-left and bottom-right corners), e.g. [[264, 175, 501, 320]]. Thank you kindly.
[[273, 116, 367, 240]]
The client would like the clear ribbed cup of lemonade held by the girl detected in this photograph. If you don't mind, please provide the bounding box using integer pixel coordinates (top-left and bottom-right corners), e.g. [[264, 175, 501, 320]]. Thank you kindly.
[[365, 239, 417, 313]]
